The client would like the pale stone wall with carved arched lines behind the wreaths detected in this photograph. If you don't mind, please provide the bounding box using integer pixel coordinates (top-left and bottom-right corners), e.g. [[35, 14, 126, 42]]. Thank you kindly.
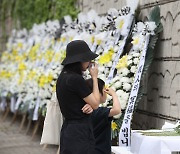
[[79, 0, 180, 129]]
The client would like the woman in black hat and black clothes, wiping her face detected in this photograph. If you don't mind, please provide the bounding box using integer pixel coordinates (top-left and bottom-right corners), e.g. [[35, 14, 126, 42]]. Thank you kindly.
[[56, 40, 100, 154]]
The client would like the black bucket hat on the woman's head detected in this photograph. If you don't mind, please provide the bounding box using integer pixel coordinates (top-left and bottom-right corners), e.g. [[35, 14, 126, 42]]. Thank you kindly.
[[62, 40, 98, 65]]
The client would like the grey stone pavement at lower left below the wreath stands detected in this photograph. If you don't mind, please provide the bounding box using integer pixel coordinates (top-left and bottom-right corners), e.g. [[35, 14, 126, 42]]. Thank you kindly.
[[0, 114, 58, 154]]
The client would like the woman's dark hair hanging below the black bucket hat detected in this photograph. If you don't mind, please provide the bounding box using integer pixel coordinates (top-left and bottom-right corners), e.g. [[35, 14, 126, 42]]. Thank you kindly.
[[62, 62, 83, 75]]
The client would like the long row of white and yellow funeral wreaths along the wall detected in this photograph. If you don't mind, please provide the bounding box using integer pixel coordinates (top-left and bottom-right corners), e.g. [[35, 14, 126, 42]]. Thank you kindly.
[[0, 0, 160, 140]]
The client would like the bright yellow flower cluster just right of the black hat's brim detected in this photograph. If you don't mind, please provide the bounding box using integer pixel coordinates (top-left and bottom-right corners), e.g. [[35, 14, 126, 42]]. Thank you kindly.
[[99, 48, 114, 65]]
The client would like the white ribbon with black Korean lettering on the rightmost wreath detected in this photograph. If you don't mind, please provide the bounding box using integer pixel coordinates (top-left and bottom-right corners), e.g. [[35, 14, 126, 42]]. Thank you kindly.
[[119, 35, 149, 146]]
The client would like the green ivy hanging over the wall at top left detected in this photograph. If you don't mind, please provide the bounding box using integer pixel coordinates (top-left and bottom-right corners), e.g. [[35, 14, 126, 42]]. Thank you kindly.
[[0, 0, 79, 30]]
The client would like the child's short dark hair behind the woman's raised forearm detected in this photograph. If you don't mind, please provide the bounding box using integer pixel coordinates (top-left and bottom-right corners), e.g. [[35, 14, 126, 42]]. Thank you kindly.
[[86, 78, 105, 95]]
